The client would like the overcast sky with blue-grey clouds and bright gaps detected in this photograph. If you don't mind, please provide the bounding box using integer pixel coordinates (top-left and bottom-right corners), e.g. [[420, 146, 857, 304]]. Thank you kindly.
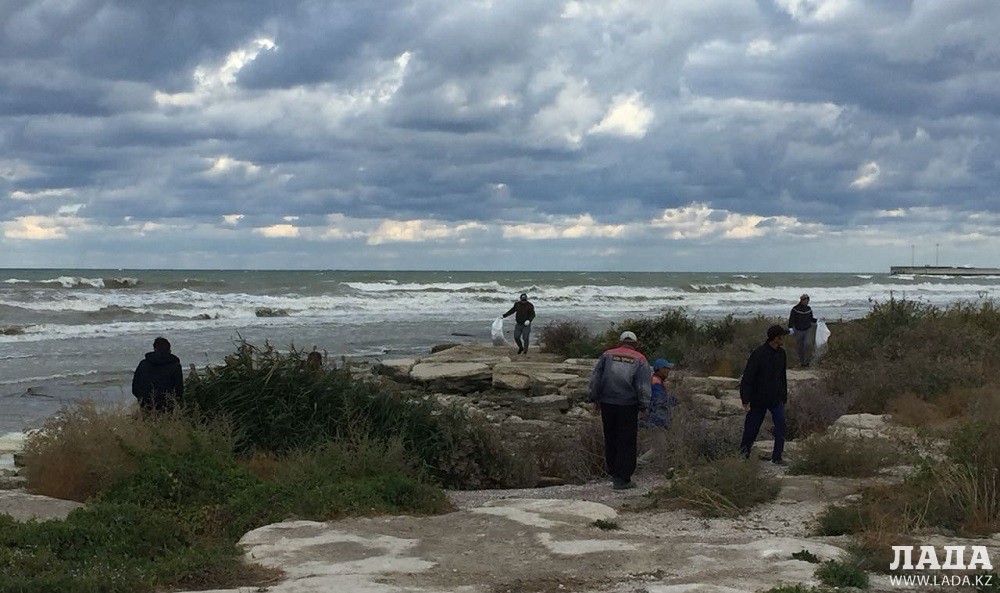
[[0, 0, 1000, 272]]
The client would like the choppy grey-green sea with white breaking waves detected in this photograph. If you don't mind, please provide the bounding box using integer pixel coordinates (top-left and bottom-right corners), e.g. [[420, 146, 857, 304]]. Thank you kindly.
[[0, 269, 1000, 441]]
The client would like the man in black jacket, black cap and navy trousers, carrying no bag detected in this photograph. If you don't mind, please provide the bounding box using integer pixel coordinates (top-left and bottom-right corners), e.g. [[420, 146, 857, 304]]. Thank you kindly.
[[740, 325, 788, 465]]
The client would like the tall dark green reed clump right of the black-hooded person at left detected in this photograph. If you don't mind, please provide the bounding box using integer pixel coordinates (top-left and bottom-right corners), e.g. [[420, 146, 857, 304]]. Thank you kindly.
[[184, 342, 524, 488]]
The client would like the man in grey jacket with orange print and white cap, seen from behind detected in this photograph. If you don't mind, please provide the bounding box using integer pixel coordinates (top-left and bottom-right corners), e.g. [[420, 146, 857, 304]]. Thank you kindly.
[[590, 331, 653, 490]]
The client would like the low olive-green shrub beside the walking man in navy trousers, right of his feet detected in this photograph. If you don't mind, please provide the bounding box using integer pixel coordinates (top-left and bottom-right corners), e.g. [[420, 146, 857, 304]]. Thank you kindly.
[[788, 434, 898, 478]]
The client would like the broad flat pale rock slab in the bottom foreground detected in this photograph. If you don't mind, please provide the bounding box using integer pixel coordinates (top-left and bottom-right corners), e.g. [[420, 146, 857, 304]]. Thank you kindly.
[[174, 498, 842, 593]]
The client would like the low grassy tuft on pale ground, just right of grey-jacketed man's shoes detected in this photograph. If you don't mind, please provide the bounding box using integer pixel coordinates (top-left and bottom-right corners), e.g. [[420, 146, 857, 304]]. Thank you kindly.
[[653, 457, 781, 517]]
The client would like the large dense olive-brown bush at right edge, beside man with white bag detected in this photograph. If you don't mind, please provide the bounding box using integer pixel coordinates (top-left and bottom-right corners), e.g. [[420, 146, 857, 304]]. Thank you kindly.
[[823, 298, 1000, 413]]
